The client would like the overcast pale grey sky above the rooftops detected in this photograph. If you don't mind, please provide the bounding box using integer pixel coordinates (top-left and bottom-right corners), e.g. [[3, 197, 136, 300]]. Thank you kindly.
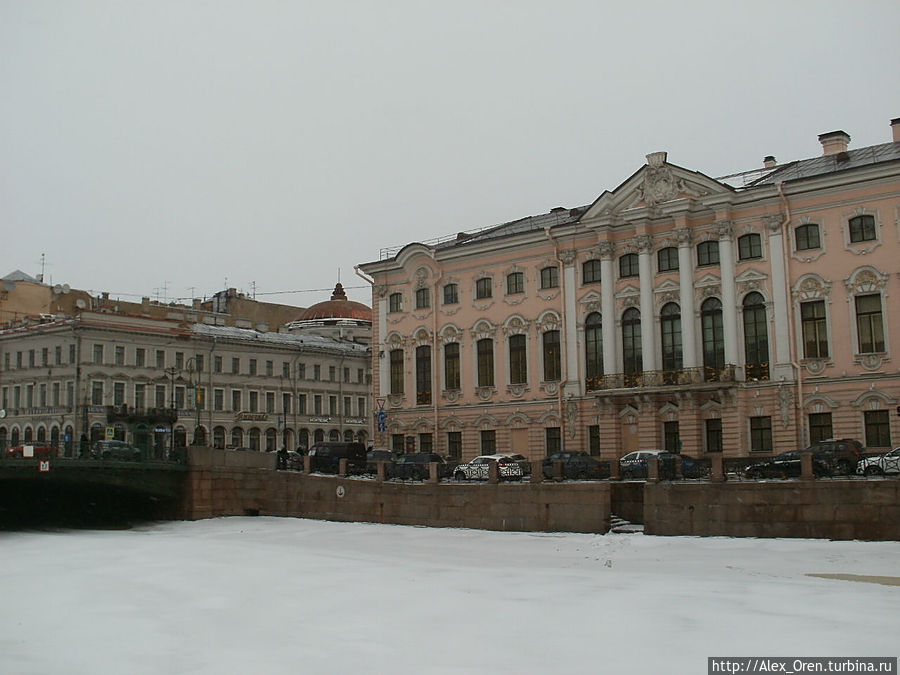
[[0, 0, 900, 306]]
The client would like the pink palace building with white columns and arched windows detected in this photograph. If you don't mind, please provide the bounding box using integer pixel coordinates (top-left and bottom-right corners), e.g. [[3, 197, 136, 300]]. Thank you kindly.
[[360, 120, 900, 458]]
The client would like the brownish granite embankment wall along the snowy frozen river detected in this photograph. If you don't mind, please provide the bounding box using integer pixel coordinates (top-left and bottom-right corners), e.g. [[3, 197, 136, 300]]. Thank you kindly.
[[181, 448, 900, 541]]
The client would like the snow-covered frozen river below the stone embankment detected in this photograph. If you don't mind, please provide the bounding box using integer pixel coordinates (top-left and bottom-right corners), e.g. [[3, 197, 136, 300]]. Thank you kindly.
[[0, 518, 900, 675]]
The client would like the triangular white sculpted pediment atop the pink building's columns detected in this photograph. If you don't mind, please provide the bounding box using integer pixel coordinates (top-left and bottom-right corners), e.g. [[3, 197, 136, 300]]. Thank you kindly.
[[581, 152, 734, 221]]
